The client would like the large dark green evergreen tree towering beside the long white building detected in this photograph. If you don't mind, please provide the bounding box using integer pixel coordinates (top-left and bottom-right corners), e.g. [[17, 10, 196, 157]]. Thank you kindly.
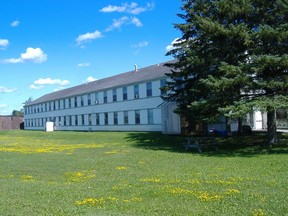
[[165, 0, 288, 142]]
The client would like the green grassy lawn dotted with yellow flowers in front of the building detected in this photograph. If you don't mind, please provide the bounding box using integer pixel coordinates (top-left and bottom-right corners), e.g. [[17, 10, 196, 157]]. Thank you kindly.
[[0, 131, 288, 216]]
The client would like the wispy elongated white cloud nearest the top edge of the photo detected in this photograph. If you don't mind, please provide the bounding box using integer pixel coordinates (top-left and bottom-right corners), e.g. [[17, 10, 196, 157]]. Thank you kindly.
[[100, 2, 154, 15]]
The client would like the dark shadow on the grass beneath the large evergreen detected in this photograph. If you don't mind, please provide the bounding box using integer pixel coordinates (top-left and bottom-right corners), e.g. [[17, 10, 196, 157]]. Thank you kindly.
[[126, 132, 288, 157]]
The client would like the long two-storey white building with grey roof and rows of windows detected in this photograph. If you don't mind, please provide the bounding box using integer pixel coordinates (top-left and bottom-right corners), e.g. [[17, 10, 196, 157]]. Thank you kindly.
[[24, 60, 180, 133]]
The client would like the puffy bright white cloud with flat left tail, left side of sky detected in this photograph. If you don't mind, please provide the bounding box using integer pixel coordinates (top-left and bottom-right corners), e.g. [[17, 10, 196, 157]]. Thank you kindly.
[[3, 47, 47, 64]]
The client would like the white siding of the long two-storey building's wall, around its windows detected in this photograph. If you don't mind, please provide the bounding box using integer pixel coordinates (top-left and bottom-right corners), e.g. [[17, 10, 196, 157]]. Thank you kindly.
[[25, 80, 168, 131]]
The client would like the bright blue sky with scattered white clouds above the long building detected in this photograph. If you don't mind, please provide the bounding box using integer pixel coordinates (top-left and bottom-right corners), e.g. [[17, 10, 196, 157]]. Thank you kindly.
[[0, 0, 182, 115]]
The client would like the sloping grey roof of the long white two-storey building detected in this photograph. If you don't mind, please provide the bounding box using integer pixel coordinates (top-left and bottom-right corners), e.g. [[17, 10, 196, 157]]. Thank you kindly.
[[26, 62, 171, 106]]
